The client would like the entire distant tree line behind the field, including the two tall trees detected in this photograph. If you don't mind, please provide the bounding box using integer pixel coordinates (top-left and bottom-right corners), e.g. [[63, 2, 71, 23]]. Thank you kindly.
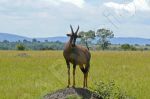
[[0, 28, 150, 51]]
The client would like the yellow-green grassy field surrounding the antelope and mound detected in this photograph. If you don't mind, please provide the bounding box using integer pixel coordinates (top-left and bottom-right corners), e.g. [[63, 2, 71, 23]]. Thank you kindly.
[[0, 51, 150, 99]]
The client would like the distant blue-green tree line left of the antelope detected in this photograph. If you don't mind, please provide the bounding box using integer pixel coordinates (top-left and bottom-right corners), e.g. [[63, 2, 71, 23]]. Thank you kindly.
[[0, 39, 64, 50]]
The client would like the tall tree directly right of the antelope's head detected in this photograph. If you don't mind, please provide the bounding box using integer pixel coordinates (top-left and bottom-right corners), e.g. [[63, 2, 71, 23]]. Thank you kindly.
[[79, 30, 95, 49]]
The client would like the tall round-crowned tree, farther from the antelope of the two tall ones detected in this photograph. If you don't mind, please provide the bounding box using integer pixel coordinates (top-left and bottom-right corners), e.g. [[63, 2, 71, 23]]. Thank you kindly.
[[96, 28, 114, 50]]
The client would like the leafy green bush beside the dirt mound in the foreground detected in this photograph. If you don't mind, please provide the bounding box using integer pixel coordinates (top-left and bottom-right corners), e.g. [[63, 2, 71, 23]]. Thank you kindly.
[[94, 81, 135, 99]]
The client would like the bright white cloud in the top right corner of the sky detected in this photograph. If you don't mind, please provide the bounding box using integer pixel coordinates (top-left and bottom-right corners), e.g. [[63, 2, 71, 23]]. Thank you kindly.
[[104, 0, 150, 12]]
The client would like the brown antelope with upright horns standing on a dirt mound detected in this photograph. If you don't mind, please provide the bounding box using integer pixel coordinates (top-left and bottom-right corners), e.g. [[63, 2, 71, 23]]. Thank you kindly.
[[63, 25, 91, 88]]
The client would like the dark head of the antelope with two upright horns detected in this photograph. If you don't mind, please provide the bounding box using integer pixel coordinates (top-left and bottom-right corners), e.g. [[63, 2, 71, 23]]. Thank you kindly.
[[67, 25, 81, 47]]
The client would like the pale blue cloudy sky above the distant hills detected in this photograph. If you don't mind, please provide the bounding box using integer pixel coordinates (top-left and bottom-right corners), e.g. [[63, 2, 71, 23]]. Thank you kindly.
[[0, 0, 150, 38]]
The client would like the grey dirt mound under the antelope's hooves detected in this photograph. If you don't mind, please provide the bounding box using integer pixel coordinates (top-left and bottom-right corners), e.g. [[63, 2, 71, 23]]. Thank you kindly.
[[44, 88, 98, 99]]
